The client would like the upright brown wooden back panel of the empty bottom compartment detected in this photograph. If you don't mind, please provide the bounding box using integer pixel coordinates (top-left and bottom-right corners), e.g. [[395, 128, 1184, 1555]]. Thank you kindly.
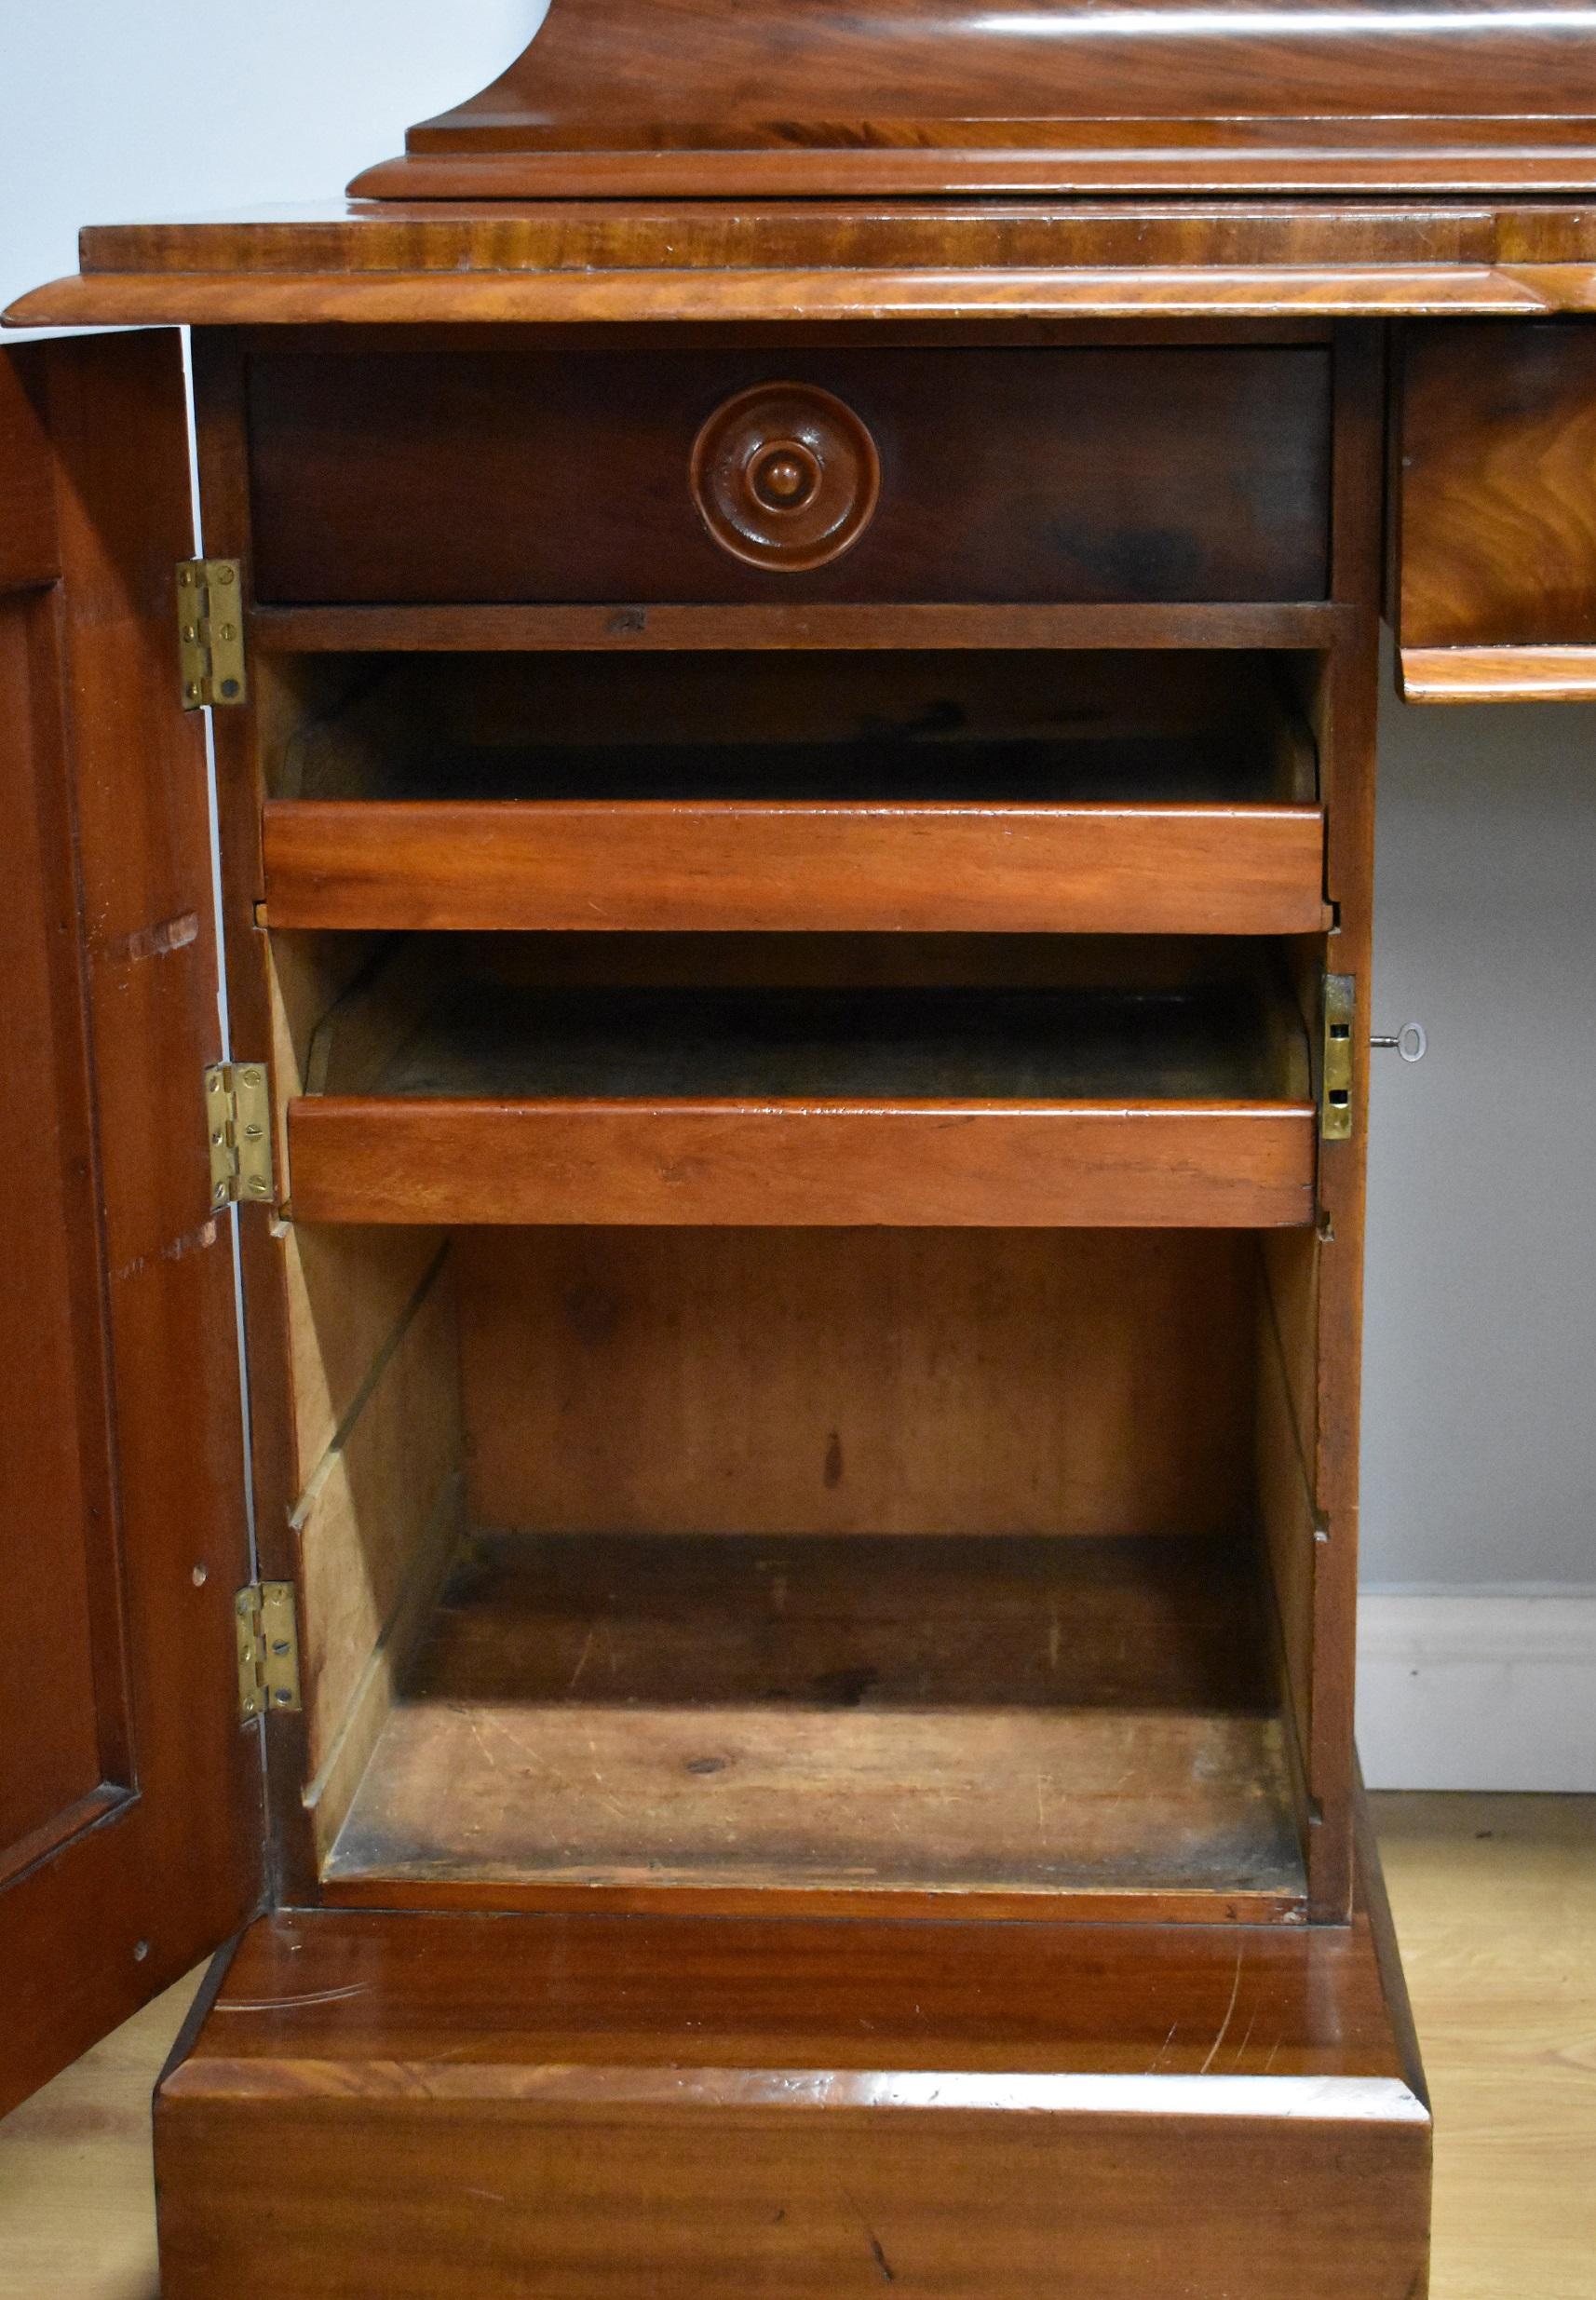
[[457, 1228, 1255, 1534]]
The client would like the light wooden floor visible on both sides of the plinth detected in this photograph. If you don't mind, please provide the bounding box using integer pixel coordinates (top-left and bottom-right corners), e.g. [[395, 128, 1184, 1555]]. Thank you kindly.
[[0, 1796, 1596, 2300]]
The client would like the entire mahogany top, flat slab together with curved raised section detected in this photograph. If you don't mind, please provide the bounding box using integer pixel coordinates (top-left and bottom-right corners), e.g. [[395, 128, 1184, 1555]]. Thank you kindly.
[[15, 0, 1596, 327]]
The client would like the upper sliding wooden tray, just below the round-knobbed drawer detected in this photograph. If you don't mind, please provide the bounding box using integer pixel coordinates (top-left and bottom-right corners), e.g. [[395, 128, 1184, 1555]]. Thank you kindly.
[[264, 653, 1330, 936]]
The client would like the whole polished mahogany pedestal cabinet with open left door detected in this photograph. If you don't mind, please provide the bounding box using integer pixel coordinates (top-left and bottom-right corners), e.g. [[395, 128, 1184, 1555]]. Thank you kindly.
[[0, 0, 1596, 2300]]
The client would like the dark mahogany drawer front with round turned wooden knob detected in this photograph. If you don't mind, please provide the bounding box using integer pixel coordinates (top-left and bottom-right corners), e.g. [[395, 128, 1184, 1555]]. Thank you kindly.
[[250, 345, 1332, 605]]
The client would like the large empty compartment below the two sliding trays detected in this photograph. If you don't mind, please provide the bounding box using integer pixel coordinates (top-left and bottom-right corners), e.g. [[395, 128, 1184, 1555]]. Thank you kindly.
[[297, 1228, 1311, 1900]]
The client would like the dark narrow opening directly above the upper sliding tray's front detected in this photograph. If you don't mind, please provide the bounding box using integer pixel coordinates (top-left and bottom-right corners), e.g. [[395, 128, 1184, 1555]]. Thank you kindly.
[[264, 646, 1318, 805]]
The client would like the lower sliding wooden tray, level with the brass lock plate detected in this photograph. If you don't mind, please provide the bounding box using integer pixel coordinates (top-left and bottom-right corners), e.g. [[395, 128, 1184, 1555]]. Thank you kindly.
[[288, 982, 1316, 1228]]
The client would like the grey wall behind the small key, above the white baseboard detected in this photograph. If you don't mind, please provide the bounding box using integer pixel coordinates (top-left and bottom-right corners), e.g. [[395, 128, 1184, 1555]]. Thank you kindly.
[[1364, 657, 1596, 1587]]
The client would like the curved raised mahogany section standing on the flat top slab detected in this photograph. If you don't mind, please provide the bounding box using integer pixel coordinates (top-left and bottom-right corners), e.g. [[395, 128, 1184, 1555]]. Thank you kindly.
[[352, 0, 1596, 197]]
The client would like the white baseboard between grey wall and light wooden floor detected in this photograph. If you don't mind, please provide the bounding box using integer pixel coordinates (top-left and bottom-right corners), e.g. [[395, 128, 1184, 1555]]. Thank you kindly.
[[1357, 1590, 1596, 1792]]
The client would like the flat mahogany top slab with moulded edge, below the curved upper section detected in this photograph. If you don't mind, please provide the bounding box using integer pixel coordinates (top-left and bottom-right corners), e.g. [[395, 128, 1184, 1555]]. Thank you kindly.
[[7, 202, 1596, 329]]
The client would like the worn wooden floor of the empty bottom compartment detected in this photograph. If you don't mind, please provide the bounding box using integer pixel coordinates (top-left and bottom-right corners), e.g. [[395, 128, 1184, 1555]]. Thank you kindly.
[[327, 1534, 1302, 1916]]
